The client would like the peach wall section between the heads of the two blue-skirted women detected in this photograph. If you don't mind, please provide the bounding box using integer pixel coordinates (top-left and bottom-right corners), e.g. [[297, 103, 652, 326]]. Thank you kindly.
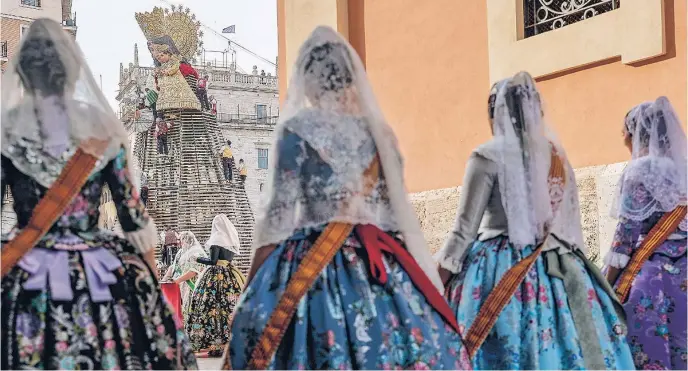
[[365, 0, 490, 192]]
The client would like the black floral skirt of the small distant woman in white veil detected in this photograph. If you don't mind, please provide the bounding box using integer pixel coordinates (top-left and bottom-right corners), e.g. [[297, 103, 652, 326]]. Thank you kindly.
[[184, 264, 246, 352]]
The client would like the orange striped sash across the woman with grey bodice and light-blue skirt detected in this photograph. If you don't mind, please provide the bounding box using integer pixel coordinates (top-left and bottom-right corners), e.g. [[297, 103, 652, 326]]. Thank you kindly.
[[464, 146, 566, 358]]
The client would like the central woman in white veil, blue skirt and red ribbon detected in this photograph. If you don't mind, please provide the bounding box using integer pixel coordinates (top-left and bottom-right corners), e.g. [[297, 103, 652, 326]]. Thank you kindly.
[[225, 27, 470, 369]]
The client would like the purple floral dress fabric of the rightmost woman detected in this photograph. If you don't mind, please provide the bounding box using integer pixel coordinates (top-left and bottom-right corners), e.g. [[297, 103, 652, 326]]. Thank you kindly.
[[611, 212, 688, 370]]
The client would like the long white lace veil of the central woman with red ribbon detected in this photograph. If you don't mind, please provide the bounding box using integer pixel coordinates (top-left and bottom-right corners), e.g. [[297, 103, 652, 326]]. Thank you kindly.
[[253, 26, 443, 291]]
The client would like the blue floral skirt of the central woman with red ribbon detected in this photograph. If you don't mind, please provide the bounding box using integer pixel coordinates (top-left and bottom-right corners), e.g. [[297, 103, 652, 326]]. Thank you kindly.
[[229, 230, 470, 370]]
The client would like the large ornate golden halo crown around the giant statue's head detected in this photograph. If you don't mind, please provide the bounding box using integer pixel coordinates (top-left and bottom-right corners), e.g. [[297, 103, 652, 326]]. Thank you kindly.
[[135, 6, 203, 59]]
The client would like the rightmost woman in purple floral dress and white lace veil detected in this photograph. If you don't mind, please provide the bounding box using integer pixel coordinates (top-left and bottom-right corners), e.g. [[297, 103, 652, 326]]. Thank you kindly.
[[605, 97, 688, 370]]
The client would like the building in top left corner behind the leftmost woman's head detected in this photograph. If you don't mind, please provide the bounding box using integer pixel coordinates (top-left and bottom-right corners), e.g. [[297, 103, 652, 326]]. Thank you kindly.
[[0, 0, 77, 71]]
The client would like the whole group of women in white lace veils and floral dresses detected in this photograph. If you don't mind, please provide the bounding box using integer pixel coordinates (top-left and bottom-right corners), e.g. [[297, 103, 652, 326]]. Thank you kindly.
[[0, 20, 688, 370]]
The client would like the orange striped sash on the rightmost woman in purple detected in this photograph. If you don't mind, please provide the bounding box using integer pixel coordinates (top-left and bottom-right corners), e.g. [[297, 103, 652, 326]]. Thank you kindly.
[[614, 206, 686, 303]]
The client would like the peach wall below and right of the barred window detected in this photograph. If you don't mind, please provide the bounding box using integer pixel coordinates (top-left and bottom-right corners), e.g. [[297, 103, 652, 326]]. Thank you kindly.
[[538, 0, 688, 171]]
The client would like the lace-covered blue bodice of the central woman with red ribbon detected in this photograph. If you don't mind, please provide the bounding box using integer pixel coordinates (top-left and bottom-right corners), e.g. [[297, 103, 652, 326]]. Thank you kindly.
[[254, 112, 398, 246]]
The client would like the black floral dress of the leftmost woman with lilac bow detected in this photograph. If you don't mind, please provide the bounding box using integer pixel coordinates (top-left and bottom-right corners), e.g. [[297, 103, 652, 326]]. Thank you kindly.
[[0, 149, 196, 370]]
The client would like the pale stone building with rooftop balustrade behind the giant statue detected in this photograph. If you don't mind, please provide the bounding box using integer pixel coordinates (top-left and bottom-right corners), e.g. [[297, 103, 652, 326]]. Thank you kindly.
[[116, 46, 279, 214]]
